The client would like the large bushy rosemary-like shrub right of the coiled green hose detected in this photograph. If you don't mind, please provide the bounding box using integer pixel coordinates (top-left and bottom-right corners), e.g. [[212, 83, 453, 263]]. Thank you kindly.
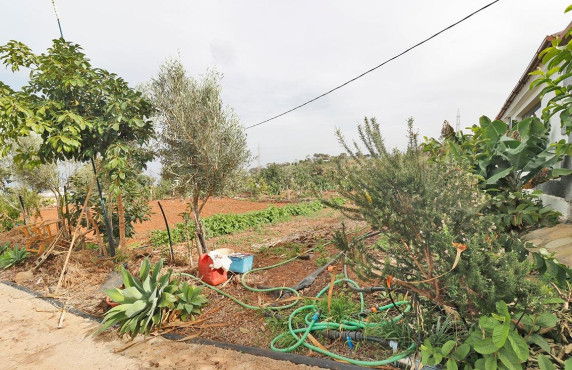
[[332, 119, 536, 316]]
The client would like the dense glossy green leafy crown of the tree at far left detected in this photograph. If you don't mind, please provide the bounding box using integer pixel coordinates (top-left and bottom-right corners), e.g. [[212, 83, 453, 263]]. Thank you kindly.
[[0, 39, 153, 182]]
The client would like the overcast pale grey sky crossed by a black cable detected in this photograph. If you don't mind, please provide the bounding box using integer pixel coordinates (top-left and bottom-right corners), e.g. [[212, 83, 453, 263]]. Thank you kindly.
[[0, 0, 572, 175]]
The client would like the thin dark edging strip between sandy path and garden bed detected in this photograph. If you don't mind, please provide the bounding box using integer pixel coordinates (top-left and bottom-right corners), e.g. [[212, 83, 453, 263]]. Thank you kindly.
[[0, 280, 367, 370]]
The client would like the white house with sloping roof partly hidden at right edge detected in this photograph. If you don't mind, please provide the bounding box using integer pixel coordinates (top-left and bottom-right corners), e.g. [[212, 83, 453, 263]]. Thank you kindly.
[[497, 23, 572, 220]]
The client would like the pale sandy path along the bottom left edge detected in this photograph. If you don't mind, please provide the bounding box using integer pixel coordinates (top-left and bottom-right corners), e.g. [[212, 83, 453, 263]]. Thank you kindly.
[[0, 283, 317, 370]]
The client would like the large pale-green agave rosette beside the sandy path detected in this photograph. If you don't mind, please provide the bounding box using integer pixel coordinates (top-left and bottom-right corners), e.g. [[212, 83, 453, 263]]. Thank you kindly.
[[98, 258, 178, 337]]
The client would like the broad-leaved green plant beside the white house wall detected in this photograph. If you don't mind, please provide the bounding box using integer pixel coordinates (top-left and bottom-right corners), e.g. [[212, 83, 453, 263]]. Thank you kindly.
[[423, 116, 571, 229]]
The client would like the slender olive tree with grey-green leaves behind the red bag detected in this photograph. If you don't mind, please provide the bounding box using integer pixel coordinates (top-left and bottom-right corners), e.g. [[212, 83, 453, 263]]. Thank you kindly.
[[148, 60, 250, 253]]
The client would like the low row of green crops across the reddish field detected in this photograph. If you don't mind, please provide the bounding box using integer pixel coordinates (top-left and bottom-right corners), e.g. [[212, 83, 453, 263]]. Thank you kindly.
[[149, 199, 342, 247]]
